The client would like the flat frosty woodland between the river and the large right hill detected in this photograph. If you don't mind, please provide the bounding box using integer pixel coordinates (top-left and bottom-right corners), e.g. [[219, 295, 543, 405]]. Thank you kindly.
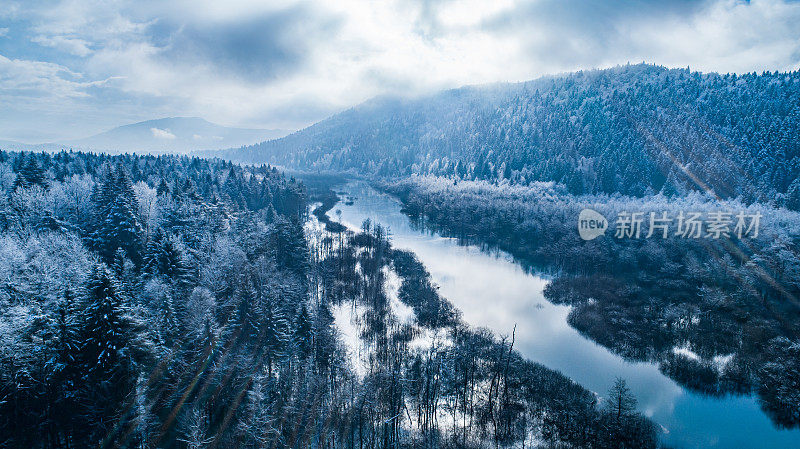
[[380, 176, 800, 428]]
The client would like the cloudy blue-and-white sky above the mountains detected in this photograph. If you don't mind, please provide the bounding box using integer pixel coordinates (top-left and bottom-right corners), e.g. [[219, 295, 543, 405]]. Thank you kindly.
[[0, 0, 800, 142]]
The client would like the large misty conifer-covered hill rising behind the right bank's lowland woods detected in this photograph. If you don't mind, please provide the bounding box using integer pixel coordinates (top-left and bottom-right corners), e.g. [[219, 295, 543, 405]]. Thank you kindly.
[[217, 64, 800, 201]]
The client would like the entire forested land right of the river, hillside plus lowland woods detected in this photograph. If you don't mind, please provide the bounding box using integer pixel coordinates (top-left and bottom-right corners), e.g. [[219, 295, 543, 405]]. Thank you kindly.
[[203, 64, 800, 446]]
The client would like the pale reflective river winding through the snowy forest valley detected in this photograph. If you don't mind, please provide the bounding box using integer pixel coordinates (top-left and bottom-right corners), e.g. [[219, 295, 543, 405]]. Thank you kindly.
[[329, 182, 800, 449]]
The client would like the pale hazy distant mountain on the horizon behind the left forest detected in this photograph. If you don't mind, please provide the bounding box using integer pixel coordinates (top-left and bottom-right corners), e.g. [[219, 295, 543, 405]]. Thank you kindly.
[[63, 117, 287, 153]]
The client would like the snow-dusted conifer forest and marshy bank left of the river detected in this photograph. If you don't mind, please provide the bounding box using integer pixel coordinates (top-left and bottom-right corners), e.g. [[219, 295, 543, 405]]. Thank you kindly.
[[0, 152, 657, 449]]
